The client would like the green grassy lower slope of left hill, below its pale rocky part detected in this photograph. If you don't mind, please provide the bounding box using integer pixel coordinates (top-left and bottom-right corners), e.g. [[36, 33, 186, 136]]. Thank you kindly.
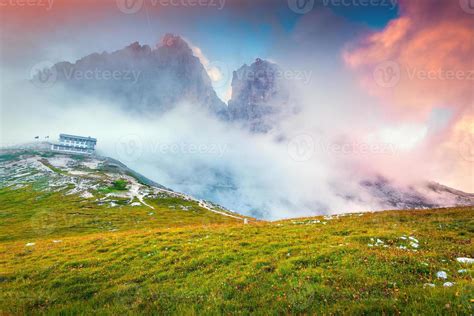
[[0, 187, 242, 241]]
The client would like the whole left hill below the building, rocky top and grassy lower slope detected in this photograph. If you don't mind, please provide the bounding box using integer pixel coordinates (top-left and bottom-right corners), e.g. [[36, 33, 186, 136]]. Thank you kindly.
[[0, 150, 244, 241]]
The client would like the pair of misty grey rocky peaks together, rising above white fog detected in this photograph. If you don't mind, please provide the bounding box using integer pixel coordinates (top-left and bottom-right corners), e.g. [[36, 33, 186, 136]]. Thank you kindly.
[[41, 34, 296, 132]]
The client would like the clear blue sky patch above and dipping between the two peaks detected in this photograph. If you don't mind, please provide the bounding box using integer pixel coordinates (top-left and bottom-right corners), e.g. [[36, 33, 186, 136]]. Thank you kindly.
[[135, 0, 398, 97]]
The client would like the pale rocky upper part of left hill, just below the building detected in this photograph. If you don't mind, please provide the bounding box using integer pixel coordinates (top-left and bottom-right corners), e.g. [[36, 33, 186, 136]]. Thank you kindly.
[[0, 149, 243, 220]]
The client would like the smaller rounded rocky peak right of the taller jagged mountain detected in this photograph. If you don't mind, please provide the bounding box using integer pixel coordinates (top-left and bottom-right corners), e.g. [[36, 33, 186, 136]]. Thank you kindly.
[[229, 59, 295, 132]]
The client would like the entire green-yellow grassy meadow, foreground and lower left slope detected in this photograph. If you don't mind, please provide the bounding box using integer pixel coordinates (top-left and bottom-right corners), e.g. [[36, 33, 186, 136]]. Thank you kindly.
[[0, 184, 474, 315]]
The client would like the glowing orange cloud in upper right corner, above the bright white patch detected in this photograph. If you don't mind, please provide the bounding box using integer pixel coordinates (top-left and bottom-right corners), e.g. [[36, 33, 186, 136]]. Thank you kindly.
[[343, 0, 474, 119]]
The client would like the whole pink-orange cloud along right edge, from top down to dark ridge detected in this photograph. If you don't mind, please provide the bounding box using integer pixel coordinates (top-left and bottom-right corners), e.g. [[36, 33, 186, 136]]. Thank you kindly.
[[343, 0, 474, 192]]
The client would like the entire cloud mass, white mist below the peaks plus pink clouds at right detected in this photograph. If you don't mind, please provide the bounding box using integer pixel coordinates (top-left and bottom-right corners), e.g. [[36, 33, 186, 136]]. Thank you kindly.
[[1, 1, 474, 219]]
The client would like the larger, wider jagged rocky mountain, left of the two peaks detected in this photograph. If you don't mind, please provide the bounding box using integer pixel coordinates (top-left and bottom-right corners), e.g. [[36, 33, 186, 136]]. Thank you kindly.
[[53, 34, 227, 117]]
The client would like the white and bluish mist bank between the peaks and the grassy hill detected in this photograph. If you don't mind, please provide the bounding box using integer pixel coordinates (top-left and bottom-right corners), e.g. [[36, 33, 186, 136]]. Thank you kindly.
[[2, 77, 444, 219]]
